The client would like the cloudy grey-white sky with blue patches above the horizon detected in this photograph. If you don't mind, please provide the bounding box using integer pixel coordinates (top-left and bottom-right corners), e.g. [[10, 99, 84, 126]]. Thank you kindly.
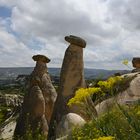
[[0, 0, 140, 69]]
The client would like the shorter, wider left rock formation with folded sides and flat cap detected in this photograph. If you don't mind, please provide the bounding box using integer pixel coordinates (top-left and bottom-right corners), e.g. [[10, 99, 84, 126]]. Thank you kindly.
[[15, 55, 57, 136]]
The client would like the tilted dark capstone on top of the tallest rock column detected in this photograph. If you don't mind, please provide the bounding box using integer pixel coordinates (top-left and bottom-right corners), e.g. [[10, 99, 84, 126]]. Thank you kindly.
[[65, 35, 86, 48]]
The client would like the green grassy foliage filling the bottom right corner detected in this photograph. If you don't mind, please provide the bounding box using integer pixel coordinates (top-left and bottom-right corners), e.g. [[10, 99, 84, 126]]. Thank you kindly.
[[72, 105, 140, 140]]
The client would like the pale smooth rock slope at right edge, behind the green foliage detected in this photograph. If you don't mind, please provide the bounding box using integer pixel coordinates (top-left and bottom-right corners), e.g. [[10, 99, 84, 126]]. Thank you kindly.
[[95, 72, 140, 115]]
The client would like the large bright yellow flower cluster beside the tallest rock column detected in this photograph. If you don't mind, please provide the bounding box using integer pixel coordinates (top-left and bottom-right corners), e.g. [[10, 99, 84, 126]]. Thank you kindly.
[[68, 76, 123, 106]]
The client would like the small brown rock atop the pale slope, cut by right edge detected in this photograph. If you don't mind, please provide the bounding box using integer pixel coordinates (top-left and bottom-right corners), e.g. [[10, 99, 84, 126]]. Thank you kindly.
[[132, 57, 140, 72]]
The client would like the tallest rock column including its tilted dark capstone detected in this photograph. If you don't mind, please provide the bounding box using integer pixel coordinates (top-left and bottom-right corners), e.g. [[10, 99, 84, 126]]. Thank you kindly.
[[48, 35, 86, 140]]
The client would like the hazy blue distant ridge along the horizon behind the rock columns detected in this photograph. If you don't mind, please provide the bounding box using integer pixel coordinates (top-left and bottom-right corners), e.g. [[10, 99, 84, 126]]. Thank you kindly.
[[0, 67, 129, 79]]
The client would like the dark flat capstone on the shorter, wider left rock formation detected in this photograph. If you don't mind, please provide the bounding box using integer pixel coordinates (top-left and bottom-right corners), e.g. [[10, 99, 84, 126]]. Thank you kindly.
[[32, 54, 50, 63]]
